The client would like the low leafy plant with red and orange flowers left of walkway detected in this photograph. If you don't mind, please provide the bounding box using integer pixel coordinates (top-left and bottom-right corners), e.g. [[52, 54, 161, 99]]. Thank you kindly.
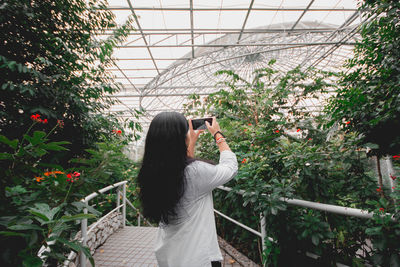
[[0, 114, 97, 266]]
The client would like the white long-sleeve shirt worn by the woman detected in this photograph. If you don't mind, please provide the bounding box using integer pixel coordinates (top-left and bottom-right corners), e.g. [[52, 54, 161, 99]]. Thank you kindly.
[[155, 150, 238, 267]]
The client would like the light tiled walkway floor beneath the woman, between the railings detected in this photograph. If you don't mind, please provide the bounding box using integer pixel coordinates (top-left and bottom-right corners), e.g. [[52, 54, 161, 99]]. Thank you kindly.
[[92, 226, 258, 267]]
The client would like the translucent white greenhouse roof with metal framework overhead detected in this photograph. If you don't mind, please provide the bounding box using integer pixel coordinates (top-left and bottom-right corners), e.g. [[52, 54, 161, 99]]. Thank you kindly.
[[103, 0, 363, 152]]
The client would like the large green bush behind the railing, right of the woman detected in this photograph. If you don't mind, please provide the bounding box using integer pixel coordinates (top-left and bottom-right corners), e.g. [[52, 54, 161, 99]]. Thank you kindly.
[[186, 62, 394, 266]]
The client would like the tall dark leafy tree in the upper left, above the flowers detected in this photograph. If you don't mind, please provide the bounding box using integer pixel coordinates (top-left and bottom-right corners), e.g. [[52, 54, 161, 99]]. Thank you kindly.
[[0, 0, 137, 170]]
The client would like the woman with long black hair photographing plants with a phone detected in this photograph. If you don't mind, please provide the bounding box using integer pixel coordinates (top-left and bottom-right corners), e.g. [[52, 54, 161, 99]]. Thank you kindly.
[[138, 112, 237, 267]]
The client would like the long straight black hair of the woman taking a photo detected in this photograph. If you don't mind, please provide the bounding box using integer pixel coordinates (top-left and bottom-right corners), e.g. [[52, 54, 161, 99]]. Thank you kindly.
[[138, 112, 192, 224]]
